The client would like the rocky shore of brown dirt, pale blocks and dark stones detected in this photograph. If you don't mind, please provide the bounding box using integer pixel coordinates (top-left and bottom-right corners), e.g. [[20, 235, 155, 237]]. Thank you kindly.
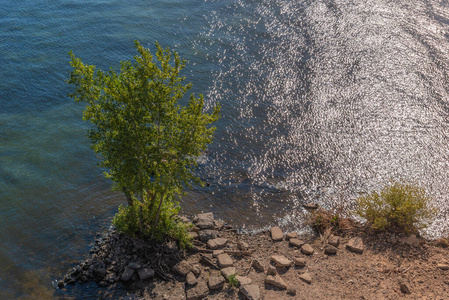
[[58, 213, 449, 300]]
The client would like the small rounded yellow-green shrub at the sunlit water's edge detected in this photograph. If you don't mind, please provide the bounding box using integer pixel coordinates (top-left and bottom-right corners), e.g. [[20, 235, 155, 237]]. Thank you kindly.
[[356, 182, 435, 234]]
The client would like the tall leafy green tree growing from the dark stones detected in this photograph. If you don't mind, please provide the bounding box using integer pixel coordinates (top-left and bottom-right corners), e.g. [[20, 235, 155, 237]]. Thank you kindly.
[[68, 41, 220, 246]]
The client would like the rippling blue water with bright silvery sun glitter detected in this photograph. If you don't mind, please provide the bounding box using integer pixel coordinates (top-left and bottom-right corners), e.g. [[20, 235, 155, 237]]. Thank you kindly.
[[0, 0, 449, 299]]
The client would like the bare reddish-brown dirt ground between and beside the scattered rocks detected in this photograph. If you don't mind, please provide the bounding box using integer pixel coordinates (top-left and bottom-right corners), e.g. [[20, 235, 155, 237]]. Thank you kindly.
[[136, 224, 449, 300]]
